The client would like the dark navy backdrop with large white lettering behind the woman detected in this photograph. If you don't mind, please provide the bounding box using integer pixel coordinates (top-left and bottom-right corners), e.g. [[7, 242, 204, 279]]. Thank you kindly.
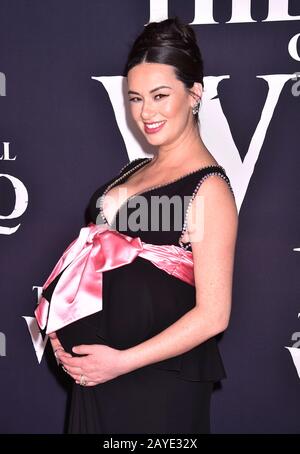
[[0, 0, 300, 433]]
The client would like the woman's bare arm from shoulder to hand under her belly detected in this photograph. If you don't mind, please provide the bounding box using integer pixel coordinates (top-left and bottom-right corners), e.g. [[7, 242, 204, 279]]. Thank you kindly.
[[58, 175, 238, 385]]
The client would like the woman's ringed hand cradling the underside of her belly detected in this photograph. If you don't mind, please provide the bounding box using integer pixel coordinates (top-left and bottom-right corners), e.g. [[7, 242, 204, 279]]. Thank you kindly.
[[59, 344, 126, 386]]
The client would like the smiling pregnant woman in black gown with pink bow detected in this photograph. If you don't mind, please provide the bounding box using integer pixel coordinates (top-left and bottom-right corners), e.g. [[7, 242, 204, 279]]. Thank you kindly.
[[36, 17, 238, 434]]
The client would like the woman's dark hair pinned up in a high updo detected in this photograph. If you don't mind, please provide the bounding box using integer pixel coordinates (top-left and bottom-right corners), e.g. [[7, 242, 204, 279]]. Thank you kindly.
[[124, 16, 204, 123]]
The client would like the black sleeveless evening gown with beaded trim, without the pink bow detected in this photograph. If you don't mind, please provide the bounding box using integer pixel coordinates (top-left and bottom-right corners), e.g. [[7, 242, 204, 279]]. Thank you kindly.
[[43, 158, 232, 434]]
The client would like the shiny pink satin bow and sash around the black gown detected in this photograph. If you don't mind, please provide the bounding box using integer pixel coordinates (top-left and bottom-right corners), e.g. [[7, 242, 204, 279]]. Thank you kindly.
[[35, 223, 195, 334]]
